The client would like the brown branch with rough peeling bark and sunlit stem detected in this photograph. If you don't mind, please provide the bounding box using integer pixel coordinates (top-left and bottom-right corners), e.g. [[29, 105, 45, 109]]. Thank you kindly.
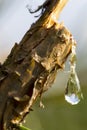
[[0, 0, 73, 130]]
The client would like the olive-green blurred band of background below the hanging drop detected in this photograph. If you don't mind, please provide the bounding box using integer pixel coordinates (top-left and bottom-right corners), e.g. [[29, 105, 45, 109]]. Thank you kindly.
[[26, 92, 87, 130]]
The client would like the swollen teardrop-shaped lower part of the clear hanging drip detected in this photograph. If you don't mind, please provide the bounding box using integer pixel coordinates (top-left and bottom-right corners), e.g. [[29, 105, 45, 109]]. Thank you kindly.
[[65, 72, 83, 105]]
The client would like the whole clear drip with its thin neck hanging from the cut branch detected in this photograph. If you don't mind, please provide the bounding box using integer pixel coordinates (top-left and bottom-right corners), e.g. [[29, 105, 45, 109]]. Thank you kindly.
[[65, 40, 83, 105]]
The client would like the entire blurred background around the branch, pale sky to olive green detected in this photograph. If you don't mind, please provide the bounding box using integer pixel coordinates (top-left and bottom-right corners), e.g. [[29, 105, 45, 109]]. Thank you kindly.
[[0, 0, 87, 130]]
